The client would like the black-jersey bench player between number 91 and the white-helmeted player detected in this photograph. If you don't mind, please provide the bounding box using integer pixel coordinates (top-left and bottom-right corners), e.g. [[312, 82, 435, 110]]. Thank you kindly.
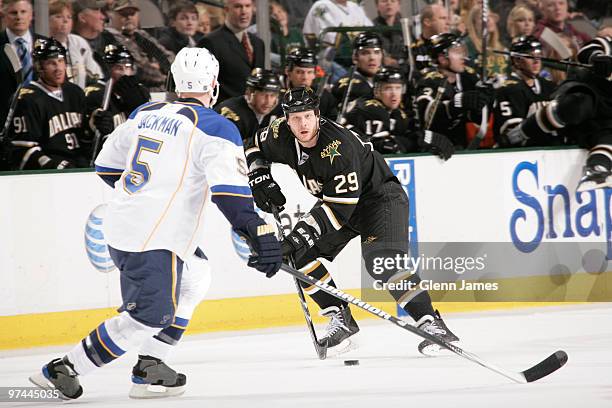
[[85, 44, 151, 136]]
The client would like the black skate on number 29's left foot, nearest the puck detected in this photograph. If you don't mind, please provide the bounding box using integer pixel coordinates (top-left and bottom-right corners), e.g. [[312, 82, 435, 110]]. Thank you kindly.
[[319, 306, 359, 356]]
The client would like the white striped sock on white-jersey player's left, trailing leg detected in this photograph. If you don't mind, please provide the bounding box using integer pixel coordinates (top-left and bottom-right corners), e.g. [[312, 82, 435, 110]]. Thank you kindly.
[[66, 312, 159, 375]]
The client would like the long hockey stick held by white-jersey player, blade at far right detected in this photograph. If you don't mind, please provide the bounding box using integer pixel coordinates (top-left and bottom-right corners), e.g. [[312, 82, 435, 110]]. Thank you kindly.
[[237, 231, 568, 384]]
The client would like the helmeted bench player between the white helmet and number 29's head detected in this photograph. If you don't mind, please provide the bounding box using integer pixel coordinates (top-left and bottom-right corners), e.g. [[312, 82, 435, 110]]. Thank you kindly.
[[214, 68, 281, 145]]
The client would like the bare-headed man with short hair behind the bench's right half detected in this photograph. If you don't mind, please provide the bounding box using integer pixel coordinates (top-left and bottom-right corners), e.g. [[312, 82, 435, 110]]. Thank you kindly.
[[412, 4, 450, 71]]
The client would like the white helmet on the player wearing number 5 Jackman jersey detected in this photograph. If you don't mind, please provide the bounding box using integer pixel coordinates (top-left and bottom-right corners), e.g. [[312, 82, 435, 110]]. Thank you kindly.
[[170, 47, 219, 106]]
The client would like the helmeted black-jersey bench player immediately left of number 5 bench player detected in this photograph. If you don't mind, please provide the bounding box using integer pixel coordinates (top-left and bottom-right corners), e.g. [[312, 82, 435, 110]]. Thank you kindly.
[[416, 33, 494, 147]]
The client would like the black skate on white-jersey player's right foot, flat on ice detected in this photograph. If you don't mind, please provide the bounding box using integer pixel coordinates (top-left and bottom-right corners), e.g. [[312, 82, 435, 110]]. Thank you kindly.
[[130, 356, 187, 398]]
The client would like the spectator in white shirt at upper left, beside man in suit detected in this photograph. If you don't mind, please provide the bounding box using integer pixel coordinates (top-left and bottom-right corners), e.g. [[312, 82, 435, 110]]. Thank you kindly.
[[49, 0, 104, 89]]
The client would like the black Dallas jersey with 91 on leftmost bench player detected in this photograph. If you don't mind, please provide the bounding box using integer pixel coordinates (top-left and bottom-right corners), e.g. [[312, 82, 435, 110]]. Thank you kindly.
[[11, 81, 90, 169]]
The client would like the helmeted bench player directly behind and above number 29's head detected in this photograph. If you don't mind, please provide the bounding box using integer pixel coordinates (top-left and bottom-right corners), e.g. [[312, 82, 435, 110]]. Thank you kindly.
[[273, 48, 338, 118]]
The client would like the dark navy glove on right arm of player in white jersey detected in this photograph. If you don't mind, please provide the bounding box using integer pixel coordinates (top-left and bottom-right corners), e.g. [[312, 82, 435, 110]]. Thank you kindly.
[[236, 218, 283, 278]]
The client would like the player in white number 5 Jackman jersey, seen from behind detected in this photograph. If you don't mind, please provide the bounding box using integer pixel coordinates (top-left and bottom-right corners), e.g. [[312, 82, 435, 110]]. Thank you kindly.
[[30, 48, 282, 399]]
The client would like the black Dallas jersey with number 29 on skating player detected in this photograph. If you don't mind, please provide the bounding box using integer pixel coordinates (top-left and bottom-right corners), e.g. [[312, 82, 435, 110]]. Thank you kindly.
[[246, 118, 397, 234]]
